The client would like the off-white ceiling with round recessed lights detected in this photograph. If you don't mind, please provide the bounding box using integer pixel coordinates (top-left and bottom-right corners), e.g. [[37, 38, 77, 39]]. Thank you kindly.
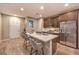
[[0, 3, 79, 18]]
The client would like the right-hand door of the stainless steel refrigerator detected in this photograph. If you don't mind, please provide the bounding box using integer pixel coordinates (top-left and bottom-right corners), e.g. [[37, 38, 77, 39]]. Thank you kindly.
[[65, 21, 76, 48]]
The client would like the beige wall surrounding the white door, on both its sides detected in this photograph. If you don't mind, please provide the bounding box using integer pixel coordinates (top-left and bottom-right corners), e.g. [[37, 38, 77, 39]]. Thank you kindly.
[[2, 14, 24, 39]]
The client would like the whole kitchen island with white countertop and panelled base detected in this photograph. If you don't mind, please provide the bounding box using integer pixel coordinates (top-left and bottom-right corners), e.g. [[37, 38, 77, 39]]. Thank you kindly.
[[26, 33, 58, 55]]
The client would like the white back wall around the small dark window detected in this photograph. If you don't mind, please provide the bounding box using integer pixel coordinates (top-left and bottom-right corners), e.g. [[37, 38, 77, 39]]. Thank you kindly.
[[26, 18, 43, 32]]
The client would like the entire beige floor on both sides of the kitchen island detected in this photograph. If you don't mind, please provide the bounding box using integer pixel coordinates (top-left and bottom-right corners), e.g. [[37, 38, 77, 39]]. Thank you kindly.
[[0, 38, 79, 55]]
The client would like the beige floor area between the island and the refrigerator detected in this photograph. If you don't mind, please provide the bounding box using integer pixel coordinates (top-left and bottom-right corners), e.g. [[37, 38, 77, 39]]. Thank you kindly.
[[55, 43, 79, 55]]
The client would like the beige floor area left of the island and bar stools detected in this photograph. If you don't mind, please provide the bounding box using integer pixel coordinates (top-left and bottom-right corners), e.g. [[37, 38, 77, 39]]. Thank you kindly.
[[0, 38, 29, 55]]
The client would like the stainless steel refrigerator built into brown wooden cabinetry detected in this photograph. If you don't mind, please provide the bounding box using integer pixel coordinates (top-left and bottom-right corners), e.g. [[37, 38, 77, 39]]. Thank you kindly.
[[60, 21, 77, 48]]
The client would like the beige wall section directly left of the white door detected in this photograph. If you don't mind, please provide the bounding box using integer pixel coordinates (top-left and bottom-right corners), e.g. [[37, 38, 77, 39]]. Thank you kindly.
[[2, 15, 9, 39]]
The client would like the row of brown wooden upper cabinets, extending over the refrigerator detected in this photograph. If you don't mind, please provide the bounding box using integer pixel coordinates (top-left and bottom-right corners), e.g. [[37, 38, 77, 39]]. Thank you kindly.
[[44, 11, 77, 28]]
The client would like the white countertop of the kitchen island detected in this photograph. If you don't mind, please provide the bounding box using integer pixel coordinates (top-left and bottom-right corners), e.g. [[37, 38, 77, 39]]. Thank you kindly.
[[26, 33, 58, 42]]
